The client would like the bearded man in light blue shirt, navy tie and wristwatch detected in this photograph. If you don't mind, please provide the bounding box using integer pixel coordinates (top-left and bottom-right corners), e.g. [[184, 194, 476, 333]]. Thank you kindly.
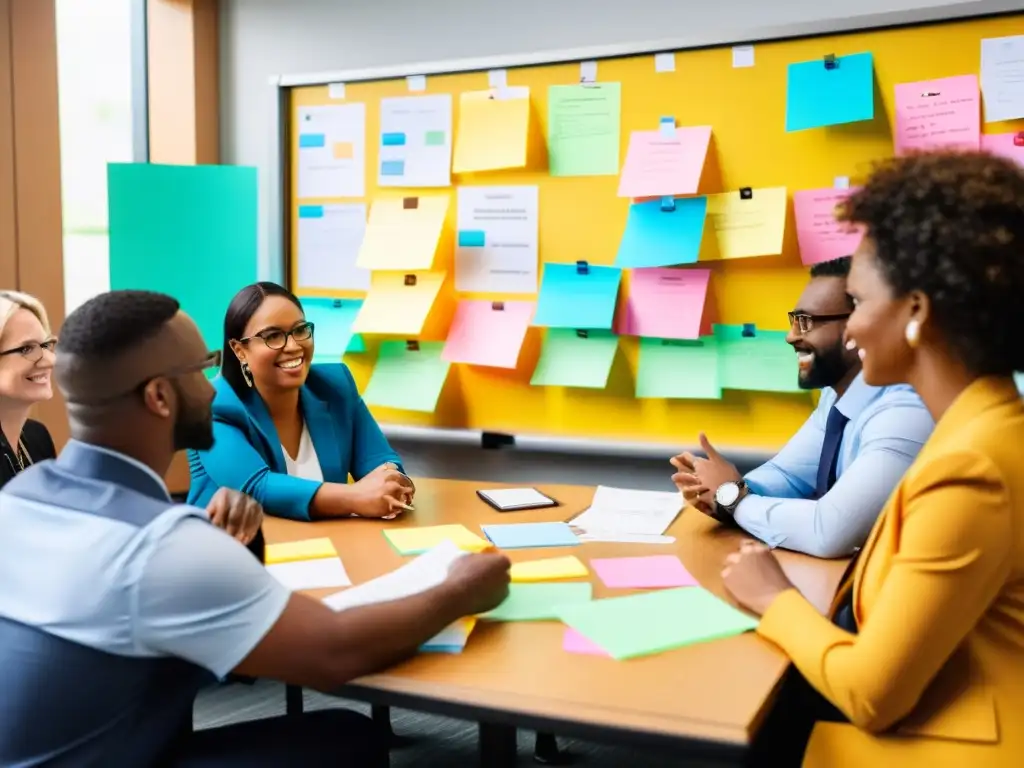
[[672, 257, 935, 557]]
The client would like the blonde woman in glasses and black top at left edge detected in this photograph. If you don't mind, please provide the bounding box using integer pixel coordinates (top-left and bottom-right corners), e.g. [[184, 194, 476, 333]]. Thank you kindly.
[[0, 291, 57, 487]]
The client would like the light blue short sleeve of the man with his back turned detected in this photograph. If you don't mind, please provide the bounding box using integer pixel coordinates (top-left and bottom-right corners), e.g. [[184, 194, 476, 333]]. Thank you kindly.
[[133, 517, 291, 678]]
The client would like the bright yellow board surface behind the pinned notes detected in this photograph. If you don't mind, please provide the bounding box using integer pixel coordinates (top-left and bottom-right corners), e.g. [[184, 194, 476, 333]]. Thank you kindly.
[[289, 15, 1024, 449]]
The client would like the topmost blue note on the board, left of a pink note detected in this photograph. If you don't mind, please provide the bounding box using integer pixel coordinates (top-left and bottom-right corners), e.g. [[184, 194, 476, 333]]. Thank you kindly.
[[785, 53, 874, 131]]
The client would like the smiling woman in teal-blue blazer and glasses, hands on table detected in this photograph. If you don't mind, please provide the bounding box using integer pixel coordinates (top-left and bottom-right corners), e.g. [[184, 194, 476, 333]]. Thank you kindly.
[[188, 283, 415, 520]]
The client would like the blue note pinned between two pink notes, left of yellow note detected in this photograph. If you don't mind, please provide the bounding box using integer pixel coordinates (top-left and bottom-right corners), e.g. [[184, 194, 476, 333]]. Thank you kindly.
[[615, 198, 708, 267]]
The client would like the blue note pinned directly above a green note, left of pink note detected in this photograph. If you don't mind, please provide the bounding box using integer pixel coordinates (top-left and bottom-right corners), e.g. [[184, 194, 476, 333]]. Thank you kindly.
[[534, 263, 623, 330]]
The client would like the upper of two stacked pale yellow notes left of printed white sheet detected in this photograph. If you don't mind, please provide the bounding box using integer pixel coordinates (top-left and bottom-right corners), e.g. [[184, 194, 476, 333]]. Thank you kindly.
[[355, 195, 449, 269]]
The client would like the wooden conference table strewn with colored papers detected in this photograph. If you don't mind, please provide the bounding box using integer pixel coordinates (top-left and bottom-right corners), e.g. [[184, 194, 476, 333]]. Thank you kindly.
[[264, 479, 846, 768]]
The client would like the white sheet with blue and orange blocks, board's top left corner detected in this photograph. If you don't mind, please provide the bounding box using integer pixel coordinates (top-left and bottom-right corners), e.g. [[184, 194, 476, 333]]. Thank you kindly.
[[298, 103, 367, 198]]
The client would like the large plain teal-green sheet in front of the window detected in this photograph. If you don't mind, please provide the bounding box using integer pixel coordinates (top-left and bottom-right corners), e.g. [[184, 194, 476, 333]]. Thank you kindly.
[[106, 163, 258, 349]]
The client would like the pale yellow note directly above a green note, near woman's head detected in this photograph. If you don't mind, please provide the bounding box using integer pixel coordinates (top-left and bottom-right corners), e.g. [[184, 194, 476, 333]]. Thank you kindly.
[[352, 272, 445, 338]]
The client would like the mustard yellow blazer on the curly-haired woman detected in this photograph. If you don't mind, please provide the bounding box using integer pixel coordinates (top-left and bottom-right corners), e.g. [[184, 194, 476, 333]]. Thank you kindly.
[[758, 378, 1024, 768]]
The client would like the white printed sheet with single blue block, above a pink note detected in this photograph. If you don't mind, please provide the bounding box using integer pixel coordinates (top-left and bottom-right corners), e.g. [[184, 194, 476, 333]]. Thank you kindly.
[[455, 186, 539, 294]]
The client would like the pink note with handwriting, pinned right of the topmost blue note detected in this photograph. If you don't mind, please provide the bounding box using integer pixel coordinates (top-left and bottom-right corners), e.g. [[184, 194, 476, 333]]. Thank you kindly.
[[896, 75, 981, 156]]
